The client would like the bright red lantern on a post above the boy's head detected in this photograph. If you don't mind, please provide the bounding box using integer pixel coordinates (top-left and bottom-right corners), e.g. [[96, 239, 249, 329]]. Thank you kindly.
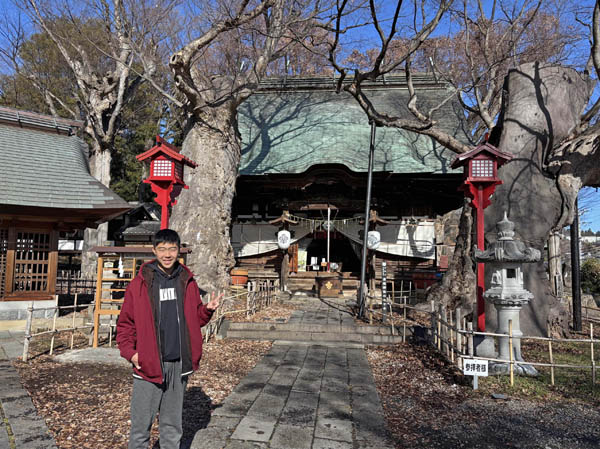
[[136, 136, 197, 229]]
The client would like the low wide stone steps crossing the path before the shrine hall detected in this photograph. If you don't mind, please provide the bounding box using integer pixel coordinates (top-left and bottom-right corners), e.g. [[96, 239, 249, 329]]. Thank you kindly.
[[220, 298, 402, 345]]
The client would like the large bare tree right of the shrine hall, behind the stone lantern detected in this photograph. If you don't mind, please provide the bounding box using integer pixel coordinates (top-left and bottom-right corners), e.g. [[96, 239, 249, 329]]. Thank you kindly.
[[330, 0, 600, 332]]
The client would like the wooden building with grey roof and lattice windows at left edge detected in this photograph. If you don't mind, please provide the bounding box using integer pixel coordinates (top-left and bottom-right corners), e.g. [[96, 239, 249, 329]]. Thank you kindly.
[[0, 108, 130, 319]]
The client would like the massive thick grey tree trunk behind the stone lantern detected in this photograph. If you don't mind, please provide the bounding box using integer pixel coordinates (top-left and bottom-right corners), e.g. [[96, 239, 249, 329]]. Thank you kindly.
[[485, 63, 588, 335]]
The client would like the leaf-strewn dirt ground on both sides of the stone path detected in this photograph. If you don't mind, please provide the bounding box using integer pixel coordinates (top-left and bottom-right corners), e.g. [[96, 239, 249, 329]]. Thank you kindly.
[[16, 306, 600, 449]]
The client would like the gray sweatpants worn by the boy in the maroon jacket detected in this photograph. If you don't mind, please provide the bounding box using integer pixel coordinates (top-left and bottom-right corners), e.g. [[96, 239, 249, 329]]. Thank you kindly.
[[128, 361, 187, 449]]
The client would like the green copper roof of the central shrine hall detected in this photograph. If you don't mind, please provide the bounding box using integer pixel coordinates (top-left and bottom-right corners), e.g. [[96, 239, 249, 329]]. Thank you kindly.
[[238, 80, 467, 175]]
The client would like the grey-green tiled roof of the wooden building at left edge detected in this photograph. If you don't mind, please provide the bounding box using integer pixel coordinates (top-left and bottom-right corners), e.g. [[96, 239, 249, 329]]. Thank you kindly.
[[0, 123, 131, 215]]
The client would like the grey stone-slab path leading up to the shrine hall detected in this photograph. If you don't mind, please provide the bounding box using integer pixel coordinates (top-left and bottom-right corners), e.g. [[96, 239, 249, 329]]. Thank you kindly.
[[191, 301, 392, 449]]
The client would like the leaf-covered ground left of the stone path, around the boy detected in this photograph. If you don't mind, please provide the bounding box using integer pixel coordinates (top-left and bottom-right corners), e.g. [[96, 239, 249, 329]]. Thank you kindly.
[[15, 340, 271, 449]]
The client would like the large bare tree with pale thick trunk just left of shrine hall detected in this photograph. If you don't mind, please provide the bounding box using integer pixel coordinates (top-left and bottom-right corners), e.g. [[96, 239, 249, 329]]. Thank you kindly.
[[169, 0, 359, 288]]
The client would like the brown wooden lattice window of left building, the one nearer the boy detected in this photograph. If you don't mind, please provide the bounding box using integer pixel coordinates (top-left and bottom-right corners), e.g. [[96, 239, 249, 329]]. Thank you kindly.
[[13, 232, 51, 292]]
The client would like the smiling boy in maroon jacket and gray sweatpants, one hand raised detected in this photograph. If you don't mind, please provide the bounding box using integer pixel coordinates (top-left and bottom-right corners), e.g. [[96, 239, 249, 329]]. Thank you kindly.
[[117, 229, 223, 449]]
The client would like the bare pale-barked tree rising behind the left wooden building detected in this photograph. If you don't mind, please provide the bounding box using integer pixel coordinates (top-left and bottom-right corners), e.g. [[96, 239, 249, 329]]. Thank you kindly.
[[2, 0, 178, 276]]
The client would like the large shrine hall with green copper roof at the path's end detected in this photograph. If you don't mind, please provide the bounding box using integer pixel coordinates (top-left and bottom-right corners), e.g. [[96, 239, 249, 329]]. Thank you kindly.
[[231, 75, 469, 289]]
